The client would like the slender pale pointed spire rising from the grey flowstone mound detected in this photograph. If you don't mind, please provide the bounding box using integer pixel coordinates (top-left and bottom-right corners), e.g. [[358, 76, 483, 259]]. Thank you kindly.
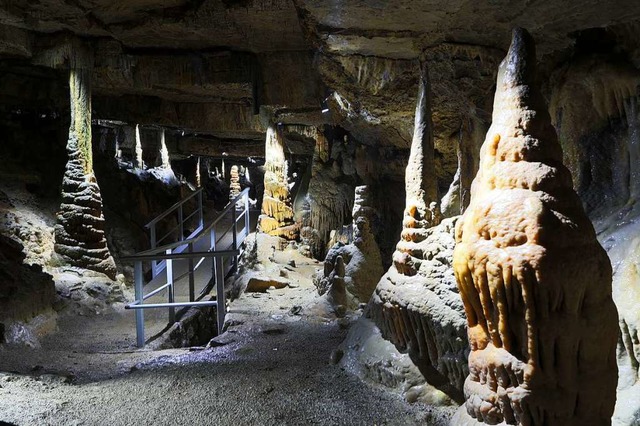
[[393, 62, 440, 275]]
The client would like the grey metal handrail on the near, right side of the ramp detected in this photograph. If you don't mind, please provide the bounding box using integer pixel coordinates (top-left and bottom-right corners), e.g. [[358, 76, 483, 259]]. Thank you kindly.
[[121, 188, 250, 347]]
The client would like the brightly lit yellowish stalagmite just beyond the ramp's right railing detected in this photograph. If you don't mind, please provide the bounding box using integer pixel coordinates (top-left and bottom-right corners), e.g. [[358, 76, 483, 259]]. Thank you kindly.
[[258, 125, 298, 240]]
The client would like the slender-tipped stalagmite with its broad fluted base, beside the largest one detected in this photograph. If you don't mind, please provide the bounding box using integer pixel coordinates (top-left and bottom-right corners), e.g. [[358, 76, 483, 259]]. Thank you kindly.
[[369, 60, 468, 402]]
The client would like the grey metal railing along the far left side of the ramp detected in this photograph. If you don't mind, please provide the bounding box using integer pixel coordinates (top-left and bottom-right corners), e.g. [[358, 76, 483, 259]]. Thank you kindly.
[[144, 188, 204, 277]]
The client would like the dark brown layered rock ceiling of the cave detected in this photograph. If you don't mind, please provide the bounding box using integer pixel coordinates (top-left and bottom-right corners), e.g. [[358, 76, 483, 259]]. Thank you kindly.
[[0, 0, 640, 166]]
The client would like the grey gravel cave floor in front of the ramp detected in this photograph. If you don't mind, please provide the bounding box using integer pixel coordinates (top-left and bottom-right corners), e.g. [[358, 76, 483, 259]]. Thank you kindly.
[[0, 250, 444, 425]]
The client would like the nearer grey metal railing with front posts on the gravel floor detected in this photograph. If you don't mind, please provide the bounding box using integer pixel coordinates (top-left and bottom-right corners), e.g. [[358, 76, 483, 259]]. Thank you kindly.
[[121, 188, 250, 347]]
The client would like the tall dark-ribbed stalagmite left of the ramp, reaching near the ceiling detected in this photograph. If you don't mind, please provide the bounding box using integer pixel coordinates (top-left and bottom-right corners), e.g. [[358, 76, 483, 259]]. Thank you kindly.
[[55, 45, 116, 278]]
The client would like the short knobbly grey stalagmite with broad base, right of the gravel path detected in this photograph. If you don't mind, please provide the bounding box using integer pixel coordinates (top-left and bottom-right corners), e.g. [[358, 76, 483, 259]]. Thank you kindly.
[[314, 186, 384, 308]]
